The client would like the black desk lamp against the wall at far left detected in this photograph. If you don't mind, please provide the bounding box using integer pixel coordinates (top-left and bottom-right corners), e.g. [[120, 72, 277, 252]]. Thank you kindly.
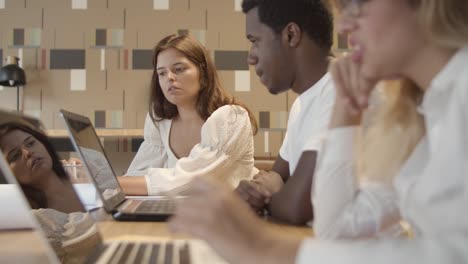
[[0, 56, 26, 112]]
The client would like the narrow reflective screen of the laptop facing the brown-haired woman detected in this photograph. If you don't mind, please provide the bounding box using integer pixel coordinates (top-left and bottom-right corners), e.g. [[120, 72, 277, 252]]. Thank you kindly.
[[60, 110, 125, 211]]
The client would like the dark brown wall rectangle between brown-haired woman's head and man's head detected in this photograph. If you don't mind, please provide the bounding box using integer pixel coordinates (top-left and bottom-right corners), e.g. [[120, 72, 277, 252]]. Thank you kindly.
[[214, 50, 249, 71]]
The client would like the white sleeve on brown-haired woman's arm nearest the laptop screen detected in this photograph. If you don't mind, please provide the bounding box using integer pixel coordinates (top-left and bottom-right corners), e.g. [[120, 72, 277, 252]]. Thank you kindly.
[[125, 114, 167, 176]]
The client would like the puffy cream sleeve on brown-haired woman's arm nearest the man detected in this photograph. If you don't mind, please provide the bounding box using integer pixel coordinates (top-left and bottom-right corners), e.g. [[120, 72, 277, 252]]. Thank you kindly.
[[146, 105, 253, 195]]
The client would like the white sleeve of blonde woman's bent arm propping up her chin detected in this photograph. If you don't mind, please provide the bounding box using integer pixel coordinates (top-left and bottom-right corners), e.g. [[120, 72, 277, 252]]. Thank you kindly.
[[312, 127, 400, 239]]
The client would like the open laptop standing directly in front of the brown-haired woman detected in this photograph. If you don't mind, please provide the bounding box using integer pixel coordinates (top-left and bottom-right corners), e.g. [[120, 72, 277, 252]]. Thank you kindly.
[[60, 110, 183, 221]]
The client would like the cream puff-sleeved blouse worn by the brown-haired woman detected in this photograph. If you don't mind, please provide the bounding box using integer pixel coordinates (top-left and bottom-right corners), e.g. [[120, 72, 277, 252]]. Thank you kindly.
[[126, 105, 257, 195]]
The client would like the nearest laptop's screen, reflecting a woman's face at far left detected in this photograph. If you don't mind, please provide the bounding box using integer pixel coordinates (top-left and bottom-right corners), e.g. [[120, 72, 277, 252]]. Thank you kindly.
[[0, 113, 102, 263]]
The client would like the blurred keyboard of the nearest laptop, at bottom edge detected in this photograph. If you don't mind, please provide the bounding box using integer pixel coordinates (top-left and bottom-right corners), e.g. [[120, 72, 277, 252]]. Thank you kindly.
[[97, 242, 191, 264]]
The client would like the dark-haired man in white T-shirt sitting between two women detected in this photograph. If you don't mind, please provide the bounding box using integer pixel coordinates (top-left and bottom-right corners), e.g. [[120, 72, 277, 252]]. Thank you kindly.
[[236, 0, 335, 225]]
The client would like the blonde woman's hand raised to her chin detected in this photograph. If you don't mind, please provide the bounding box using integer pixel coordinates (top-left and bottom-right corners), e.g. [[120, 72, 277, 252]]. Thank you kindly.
[[329, 54, 377, 128]]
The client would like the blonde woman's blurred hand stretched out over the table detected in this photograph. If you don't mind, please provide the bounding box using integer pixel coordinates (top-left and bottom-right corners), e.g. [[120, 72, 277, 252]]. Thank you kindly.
[[170, 177, 298, 263]]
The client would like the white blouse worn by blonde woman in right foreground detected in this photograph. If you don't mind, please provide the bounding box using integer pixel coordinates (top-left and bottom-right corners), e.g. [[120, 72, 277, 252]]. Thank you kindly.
[[296, 47, 468, 263]]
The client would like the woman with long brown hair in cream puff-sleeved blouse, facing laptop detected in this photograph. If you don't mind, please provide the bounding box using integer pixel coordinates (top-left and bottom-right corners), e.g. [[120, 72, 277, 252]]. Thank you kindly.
[[119, 35, 256, 195]]
